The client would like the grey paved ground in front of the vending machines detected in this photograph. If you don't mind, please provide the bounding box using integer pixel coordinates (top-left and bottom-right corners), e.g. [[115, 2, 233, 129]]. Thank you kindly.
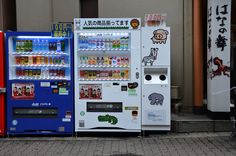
[[0, 132, 236, 156]]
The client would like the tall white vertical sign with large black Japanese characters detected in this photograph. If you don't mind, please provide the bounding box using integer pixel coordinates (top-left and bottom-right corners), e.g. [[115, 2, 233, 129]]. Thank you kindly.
[[207, 0, 231, 112]]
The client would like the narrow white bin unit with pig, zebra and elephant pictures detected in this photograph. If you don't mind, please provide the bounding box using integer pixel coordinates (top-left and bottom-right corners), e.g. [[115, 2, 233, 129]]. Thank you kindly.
[[142, 17, 171, 131]]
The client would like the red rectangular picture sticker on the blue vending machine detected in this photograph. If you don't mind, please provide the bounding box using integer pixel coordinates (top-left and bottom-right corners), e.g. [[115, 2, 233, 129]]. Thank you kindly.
[[12, 83, 35, 99]]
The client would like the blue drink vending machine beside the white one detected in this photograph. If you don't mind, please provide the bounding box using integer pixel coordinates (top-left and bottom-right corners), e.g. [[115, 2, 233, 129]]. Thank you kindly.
[[6, 32, 74, 135]]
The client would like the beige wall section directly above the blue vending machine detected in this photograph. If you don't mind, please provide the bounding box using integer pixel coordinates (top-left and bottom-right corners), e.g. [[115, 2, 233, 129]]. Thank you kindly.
[[16, 0, 80, 31]]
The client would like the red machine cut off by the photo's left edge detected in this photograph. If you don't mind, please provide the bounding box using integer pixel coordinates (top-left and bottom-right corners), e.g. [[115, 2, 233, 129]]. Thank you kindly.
[[0, 31, 6, 136]]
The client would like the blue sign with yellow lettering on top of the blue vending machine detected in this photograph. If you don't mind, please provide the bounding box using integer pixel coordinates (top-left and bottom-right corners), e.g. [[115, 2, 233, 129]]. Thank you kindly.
[[51, 23, 72, 37]]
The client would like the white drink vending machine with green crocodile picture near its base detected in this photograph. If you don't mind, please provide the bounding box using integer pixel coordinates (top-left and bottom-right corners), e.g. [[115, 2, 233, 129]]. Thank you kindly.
[[74, 18, 141, 132]]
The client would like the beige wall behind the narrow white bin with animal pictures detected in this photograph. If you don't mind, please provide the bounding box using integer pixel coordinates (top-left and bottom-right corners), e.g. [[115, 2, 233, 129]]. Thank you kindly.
[[98, 0, 192, 107]]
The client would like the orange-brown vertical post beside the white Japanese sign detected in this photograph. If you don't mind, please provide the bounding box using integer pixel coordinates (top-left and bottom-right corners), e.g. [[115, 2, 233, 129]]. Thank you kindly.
[[193, 0, 203, 112]]
